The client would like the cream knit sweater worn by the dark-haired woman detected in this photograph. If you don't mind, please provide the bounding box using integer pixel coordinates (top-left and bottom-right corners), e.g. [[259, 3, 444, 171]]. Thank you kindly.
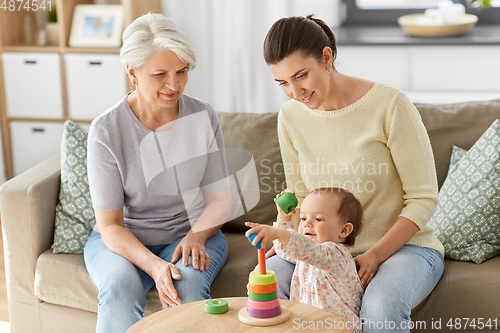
[[278, 84, 444, 255]]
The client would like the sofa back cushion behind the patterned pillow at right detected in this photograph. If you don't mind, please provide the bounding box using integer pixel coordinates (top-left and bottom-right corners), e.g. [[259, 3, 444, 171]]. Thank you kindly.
[[415, 99, 500, 187]]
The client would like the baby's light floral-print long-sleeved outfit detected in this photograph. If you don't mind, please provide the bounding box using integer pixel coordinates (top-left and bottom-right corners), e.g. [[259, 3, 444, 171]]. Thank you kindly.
[[274, 222, 363, 333]]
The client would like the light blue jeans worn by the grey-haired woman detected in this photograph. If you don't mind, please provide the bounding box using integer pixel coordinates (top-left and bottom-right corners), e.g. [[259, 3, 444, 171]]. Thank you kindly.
[[84, 230, 227, 333]]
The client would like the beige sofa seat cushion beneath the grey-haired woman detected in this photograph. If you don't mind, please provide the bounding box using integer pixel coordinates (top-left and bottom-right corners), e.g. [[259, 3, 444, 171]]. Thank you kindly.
[[35, 232, 271, 315]]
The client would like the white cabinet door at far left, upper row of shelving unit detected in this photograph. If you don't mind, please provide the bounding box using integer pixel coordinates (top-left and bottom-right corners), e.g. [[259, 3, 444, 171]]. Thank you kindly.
[[2, 52, 63, 118]]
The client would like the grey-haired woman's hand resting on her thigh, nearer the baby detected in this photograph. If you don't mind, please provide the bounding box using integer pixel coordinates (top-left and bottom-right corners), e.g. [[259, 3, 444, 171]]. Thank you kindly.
[[172, 230, 210, 271]]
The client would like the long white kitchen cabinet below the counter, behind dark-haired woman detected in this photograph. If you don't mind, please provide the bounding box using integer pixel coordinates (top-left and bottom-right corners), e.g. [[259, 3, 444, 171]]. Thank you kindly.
[[335, 45, 500, 103]]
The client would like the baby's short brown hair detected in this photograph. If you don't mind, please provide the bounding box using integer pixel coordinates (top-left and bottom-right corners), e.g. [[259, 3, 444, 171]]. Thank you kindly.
[[309, 187, 363, 246]]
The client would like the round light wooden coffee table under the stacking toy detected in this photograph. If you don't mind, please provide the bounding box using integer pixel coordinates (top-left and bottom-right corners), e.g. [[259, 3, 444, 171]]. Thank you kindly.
[[127, 297, 350, 333]]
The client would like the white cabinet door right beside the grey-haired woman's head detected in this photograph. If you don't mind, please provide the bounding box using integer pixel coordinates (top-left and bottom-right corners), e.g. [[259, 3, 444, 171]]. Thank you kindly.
[[64, 53, 127, 119]]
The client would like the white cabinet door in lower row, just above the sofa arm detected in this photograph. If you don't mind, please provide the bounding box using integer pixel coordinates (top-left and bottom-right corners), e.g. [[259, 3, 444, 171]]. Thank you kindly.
[[9, 121, 64, 176]]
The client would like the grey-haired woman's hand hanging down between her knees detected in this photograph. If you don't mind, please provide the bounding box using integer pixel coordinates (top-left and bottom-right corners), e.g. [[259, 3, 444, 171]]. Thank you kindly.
[[151, 260, 182, 308]]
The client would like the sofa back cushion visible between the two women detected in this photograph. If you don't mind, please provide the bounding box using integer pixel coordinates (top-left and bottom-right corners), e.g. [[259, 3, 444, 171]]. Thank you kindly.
[[218, 112, 285, 231]]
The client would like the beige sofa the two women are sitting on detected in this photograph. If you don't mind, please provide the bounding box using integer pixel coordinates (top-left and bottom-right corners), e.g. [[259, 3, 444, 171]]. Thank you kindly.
[[0, 101, 500, 333]]
